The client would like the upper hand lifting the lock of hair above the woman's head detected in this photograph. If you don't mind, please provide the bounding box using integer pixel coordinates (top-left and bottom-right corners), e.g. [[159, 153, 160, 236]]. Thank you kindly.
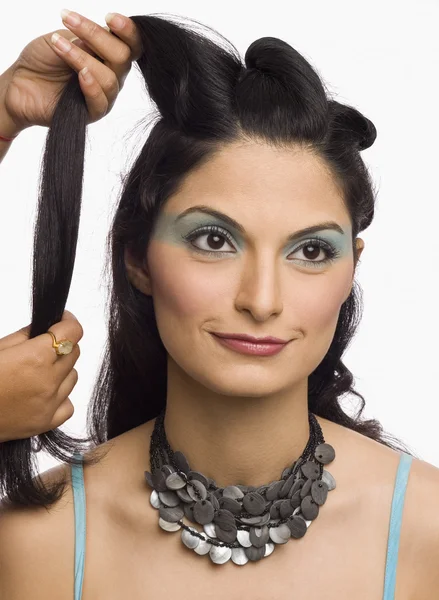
[[0, 10, 141, 138]]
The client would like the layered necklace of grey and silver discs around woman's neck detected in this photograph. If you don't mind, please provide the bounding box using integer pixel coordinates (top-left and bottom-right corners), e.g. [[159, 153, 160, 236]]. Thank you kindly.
[[145, 409, 336, 565]]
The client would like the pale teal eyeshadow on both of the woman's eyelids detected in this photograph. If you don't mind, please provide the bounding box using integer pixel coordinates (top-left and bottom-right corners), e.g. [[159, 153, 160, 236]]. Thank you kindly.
[[152, 212, 351, 258]]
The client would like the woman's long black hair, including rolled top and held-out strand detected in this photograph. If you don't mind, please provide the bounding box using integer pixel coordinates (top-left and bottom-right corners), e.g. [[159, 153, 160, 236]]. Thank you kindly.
[[0, 15, 420, 508]]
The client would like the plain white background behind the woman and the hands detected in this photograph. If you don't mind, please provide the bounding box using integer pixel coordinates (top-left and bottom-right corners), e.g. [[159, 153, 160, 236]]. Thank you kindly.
[[0, 0, 439, 478]]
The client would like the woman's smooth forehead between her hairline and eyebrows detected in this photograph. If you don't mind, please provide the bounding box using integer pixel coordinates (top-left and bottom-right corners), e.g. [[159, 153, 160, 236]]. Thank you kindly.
[[163, 144, 350, 221]]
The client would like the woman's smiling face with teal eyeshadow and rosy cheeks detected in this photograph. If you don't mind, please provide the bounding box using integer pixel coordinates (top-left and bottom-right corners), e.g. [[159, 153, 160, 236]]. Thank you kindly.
[[126, 143, 362, 396]]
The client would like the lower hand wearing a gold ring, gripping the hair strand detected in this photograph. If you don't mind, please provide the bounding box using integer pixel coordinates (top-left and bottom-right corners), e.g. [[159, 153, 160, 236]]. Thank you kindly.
[[0, 310, 83, 442]]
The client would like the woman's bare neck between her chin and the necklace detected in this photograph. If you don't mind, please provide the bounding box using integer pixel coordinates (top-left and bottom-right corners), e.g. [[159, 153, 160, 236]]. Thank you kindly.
[[164, 361, 309, 487]]
